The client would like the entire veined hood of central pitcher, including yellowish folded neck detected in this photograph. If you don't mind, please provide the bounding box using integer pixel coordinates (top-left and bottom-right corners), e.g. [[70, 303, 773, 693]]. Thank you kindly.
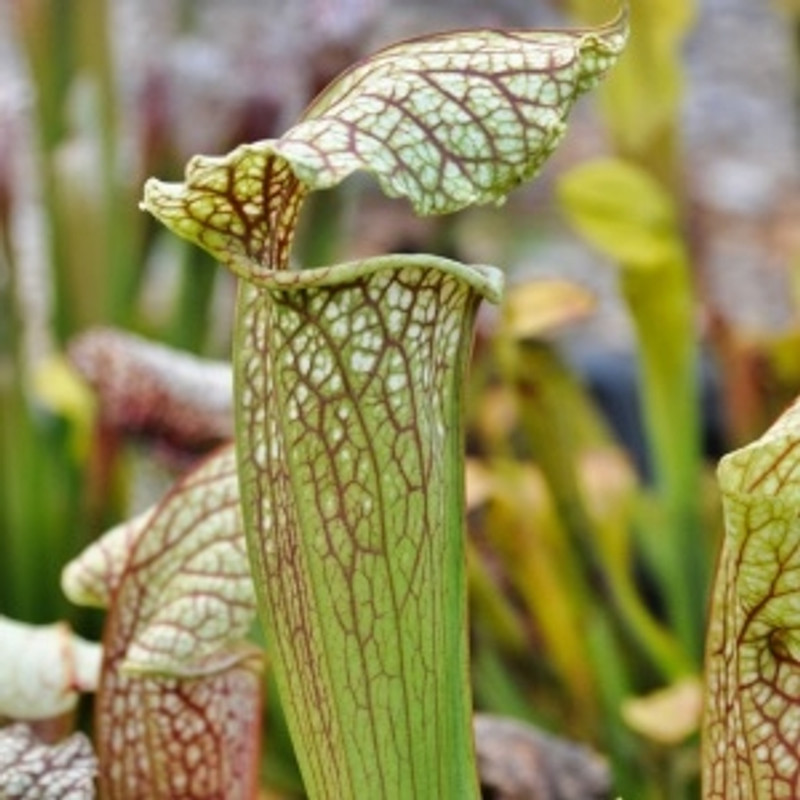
[[142, 10, 627, 272]]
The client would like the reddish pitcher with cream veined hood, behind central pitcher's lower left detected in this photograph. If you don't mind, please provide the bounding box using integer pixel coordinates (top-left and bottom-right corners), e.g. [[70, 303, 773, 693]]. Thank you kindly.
[[63, 447, 261, 800]]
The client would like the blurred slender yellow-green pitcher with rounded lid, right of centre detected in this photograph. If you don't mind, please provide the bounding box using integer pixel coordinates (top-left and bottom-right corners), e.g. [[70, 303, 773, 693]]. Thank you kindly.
[[559, 158, 708, 665]]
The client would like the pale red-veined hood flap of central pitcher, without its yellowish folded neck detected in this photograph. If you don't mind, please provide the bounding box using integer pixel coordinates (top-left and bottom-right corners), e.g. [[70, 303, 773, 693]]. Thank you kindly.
[[284, 15, 627, 214]]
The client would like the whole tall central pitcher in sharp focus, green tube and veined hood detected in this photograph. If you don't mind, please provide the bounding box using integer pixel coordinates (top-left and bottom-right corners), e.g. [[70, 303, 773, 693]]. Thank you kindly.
[[138, 9, 627, 798]]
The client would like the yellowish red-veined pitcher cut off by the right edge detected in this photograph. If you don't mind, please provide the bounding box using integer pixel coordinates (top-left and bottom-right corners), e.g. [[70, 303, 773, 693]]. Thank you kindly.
[[703, 396, 800, 800]]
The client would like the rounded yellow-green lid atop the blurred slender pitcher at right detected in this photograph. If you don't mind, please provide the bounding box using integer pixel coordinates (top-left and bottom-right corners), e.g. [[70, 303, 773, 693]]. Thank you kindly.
[[558, 158, 680, 269]]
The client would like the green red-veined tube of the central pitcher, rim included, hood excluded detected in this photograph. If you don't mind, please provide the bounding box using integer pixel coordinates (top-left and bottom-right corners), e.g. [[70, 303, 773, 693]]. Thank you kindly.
[[236, 257, 500, 799]]
